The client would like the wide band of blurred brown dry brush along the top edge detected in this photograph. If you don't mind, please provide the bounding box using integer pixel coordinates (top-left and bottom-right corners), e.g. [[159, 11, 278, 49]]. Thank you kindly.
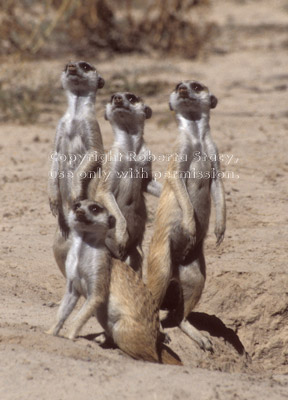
[[0, 0, 214, 57]]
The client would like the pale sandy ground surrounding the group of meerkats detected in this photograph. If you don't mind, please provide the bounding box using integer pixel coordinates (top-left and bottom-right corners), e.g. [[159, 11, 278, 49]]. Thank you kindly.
[[0, 1, 288, 400]]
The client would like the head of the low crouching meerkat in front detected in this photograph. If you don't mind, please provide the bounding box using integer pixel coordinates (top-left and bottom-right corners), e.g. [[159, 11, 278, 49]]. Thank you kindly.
[[68, 200, 115, 235]]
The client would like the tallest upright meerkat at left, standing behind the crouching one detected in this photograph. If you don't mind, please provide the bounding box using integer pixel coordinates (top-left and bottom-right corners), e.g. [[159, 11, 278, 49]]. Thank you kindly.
[[48, 61, 105, 273]]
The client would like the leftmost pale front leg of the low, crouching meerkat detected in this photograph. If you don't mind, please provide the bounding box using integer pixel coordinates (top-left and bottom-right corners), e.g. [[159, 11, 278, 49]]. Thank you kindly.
[[46, 283, 80, 336]]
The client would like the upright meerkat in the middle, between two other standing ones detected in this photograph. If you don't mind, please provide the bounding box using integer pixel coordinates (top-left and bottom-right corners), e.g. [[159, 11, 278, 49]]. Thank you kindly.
[[96, 93, 162, 274]]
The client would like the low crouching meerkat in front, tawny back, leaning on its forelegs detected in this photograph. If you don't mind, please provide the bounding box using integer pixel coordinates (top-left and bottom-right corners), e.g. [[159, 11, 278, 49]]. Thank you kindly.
[[48, 200, 181, 365]]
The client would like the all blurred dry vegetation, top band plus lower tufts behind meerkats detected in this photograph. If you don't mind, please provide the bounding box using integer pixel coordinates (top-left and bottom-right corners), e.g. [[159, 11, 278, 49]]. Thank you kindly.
[[0, 0, 217, 123]]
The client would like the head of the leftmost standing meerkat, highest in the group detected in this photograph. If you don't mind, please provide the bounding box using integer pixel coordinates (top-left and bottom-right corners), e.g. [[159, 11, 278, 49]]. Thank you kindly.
[[61, 61, 105, 96]]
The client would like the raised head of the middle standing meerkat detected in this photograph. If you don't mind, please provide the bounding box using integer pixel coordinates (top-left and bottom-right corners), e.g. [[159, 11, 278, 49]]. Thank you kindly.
[[105, 92, 152, 132]]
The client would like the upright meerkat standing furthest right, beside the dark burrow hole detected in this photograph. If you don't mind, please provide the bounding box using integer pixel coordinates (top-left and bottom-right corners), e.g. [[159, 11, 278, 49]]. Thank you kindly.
[[147, 81, 226, 349]]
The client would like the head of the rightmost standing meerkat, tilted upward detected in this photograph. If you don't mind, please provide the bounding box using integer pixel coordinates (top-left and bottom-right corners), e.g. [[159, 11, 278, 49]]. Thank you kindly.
[[169, 81, 218, 116]]
